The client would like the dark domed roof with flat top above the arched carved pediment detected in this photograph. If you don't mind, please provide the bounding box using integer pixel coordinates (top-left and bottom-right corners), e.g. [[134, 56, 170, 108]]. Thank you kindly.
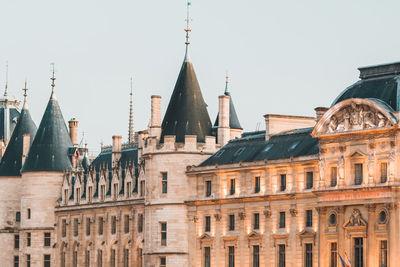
[[331, 62, 400, 111]]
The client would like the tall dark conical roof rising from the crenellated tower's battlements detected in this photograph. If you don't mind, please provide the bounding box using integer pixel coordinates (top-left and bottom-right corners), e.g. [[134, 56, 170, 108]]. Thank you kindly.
[[160, 53, 212, 143]]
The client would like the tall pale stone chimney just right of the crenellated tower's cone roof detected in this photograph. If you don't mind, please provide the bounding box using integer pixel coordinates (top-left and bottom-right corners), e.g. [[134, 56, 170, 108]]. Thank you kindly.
[[218, 95, 231, 146]]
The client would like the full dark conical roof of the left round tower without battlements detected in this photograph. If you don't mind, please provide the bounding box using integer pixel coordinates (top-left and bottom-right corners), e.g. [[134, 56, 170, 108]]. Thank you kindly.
[[22, 93, 73, 172]]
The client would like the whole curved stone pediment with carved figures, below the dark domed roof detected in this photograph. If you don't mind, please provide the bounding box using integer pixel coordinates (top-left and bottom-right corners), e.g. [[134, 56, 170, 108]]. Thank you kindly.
[[312, 98, 397, 139]]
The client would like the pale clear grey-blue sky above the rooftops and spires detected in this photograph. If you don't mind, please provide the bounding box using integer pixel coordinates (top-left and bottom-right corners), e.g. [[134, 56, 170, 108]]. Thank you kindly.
[[0, 0, 400, 153]]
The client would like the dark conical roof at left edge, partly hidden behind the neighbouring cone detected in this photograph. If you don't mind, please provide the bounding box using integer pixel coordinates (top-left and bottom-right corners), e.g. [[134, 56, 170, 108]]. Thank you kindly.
[[0, 105, 37, 176]]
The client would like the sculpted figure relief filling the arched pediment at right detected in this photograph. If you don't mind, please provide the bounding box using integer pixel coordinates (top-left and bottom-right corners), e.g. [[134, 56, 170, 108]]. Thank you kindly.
[[326, 102, 391, 133]]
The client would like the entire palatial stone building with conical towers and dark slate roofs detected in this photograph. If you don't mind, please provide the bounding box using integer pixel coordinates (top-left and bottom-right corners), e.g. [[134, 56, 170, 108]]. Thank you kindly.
[[0, 11, 400, 267]]
